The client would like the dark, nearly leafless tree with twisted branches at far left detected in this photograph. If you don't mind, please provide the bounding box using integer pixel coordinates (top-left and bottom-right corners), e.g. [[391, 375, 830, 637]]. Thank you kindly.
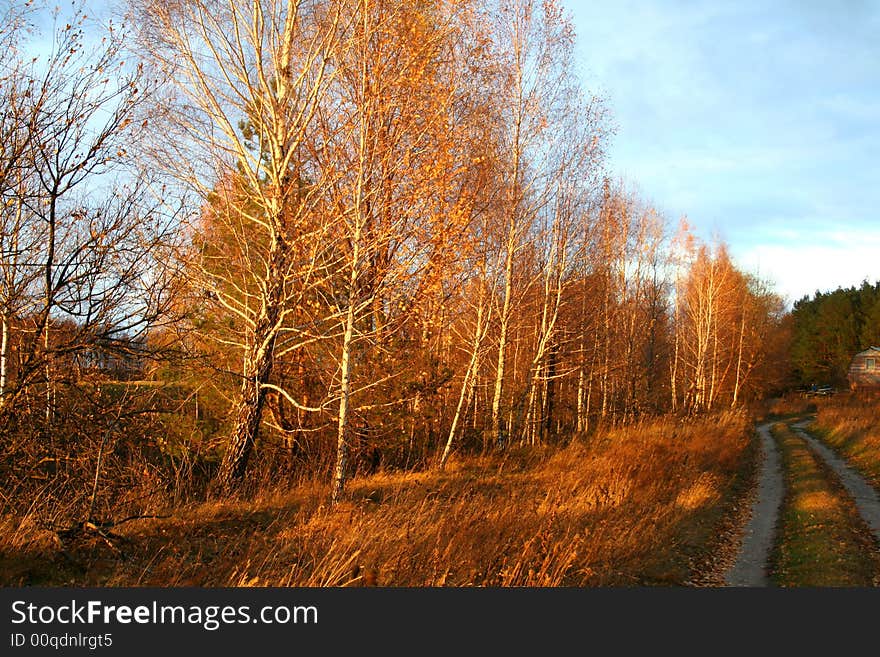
[[0, 7, 174, 426]]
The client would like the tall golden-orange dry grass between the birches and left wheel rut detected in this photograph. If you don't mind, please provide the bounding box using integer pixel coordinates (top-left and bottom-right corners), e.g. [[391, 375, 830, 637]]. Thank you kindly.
[[0, 414, 753, 587]]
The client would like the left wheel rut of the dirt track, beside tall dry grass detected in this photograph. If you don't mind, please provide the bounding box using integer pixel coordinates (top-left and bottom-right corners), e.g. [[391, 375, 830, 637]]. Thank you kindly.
[[724, 423, 784, 587]]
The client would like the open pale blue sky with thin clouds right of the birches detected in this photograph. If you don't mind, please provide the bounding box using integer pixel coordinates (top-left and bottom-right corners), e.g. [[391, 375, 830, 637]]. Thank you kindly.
[[563, 0, 880, 302]]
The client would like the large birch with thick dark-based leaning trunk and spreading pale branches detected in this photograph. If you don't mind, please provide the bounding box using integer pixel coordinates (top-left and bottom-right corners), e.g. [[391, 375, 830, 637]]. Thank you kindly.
[[134, 0, 350, 491]]
